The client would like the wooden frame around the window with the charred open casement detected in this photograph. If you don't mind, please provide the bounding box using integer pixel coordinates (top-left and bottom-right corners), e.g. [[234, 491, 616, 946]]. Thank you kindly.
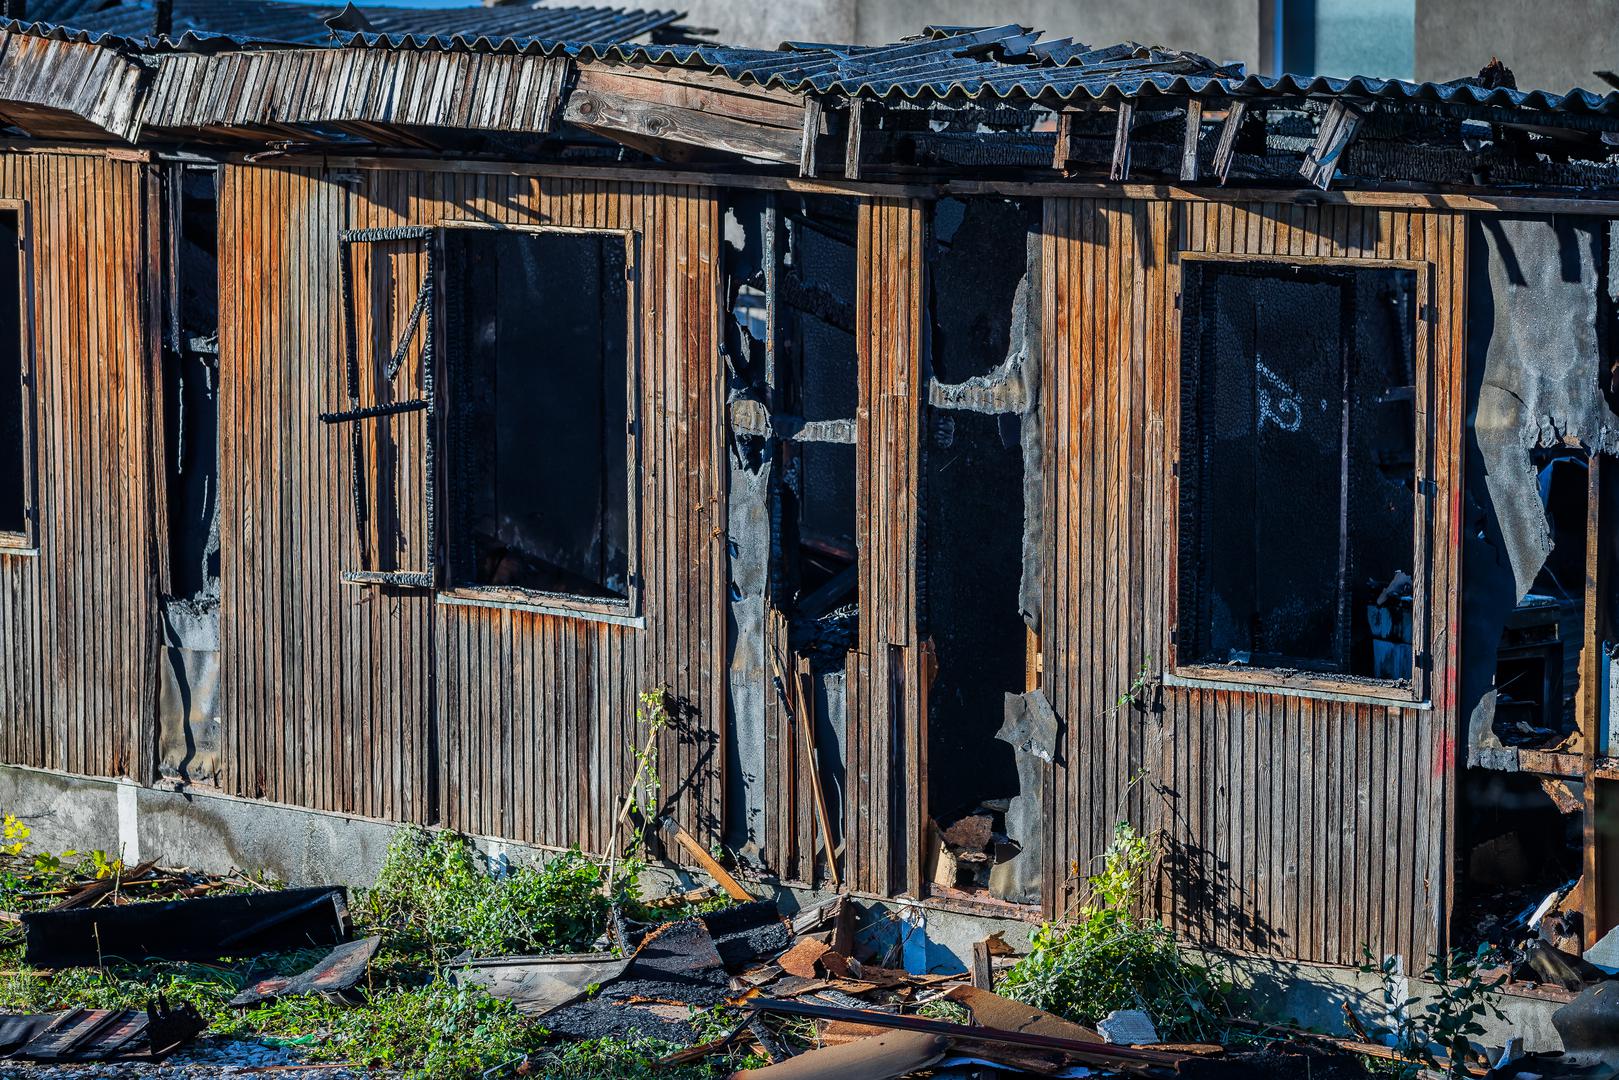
[[431, 219, 644, 623]]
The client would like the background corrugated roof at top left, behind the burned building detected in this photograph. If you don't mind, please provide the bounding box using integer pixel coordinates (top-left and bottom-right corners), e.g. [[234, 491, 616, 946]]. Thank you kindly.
[[28, 0, 683, 45]]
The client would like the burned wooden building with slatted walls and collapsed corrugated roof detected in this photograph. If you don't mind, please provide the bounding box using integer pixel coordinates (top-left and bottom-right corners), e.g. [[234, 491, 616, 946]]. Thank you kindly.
[[0, 2, 1619, 968]]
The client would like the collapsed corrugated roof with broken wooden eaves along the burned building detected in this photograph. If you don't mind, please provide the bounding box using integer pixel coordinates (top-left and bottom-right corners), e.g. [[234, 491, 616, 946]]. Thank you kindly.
[[0, 19, 1619, 193]]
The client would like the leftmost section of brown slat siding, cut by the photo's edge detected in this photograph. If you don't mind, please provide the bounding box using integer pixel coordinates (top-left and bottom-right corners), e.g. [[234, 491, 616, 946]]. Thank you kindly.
[[0, 154, 157, 777]]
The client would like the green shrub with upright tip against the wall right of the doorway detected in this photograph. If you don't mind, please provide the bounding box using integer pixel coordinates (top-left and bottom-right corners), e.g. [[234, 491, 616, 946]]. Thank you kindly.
[[996, 824, 1221, 1040]]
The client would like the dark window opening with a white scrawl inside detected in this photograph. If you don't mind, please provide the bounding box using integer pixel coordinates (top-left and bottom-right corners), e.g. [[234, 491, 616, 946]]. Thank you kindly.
[[1175, 261, 1417, 682]]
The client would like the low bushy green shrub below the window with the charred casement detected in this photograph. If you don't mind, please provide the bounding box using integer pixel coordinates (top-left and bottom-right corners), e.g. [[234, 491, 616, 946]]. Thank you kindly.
[[358, 827, 635, 960]]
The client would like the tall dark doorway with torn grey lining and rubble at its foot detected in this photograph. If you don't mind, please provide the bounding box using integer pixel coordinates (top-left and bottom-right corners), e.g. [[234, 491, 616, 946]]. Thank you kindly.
[[920, 199, 1043, 904]]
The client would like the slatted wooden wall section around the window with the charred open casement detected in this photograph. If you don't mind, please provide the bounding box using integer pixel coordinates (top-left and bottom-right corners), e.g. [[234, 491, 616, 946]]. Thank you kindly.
[[220, 167, 725, 852]]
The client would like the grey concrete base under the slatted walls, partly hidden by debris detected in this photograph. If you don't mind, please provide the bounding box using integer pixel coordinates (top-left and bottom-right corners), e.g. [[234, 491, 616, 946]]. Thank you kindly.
[[0, 766, 1561, 1051]]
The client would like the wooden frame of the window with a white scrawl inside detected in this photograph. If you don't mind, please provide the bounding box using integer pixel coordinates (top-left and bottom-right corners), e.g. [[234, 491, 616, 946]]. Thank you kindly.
[[1164, 251, 1436, 708]]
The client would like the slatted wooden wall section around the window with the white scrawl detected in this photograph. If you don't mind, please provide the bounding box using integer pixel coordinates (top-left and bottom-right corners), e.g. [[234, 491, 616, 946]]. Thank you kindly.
[[1043, 199, 1465, 965]]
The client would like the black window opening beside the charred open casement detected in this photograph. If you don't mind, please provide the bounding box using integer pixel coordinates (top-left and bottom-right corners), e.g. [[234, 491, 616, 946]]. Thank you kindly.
[[444, 228, 631, 604]]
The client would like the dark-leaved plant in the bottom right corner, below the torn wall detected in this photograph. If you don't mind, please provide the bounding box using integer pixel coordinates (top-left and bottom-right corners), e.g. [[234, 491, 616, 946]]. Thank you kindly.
[[1360, 946, 1506, 1077]]
